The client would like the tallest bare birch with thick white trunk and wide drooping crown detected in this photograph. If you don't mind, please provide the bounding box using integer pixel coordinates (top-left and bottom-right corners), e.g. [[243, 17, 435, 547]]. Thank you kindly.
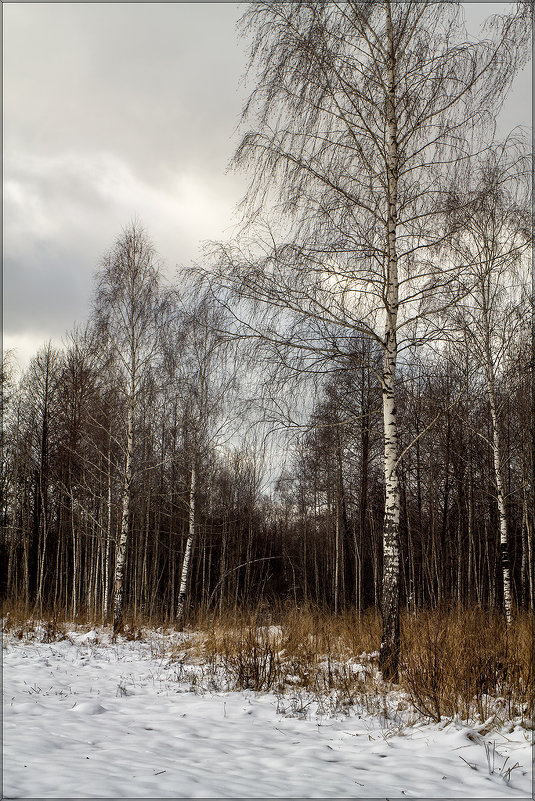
[[202, 0, 529, 680]]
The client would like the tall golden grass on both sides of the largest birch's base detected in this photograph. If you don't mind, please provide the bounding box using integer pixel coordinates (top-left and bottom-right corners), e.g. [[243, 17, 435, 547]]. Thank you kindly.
[[177, 607, 534, 726]]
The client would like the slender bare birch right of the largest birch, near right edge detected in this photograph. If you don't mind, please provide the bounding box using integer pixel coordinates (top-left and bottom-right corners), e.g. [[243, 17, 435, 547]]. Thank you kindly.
[[448, 140, 532, 624]]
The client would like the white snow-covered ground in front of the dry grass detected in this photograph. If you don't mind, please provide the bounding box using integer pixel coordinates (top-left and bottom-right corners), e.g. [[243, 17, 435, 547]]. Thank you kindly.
[[3, 629, 532, 799]]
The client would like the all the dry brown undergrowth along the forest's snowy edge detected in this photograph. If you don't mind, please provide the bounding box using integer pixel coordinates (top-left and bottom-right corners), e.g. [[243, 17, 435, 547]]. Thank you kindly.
[[3, 606, 535, 732]]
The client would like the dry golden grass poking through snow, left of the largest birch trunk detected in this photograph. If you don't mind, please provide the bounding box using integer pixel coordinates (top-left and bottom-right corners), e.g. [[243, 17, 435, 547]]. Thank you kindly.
[[170, 608, 384, 715]]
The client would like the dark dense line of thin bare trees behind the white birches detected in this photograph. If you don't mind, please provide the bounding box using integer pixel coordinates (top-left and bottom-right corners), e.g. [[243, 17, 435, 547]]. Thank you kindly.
[[0, 296, 533, 619]]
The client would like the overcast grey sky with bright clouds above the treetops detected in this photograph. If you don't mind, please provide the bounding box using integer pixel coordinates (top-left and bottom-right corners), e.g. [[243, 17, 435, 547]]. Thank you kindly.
[[3, 2, 531, 366]]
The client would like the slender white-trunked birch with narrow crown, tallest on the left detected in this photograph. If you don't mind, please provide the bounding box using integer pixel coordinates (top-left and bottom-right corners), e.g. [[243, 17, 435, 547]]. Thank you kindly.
[[95, 222, 165, 634]]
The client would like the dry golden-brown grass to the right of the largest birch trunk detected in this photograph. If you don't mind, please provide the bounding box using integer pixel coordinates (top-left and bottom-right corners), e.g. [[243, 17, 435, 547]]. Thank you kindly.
[[400, 608, 534, 725]]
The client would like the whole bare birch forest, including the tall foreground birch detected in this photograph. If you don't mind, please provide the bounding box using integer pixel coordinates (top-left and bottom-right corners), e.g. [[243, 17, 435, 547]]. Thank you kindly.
[[0, 0, 535, 681]]
